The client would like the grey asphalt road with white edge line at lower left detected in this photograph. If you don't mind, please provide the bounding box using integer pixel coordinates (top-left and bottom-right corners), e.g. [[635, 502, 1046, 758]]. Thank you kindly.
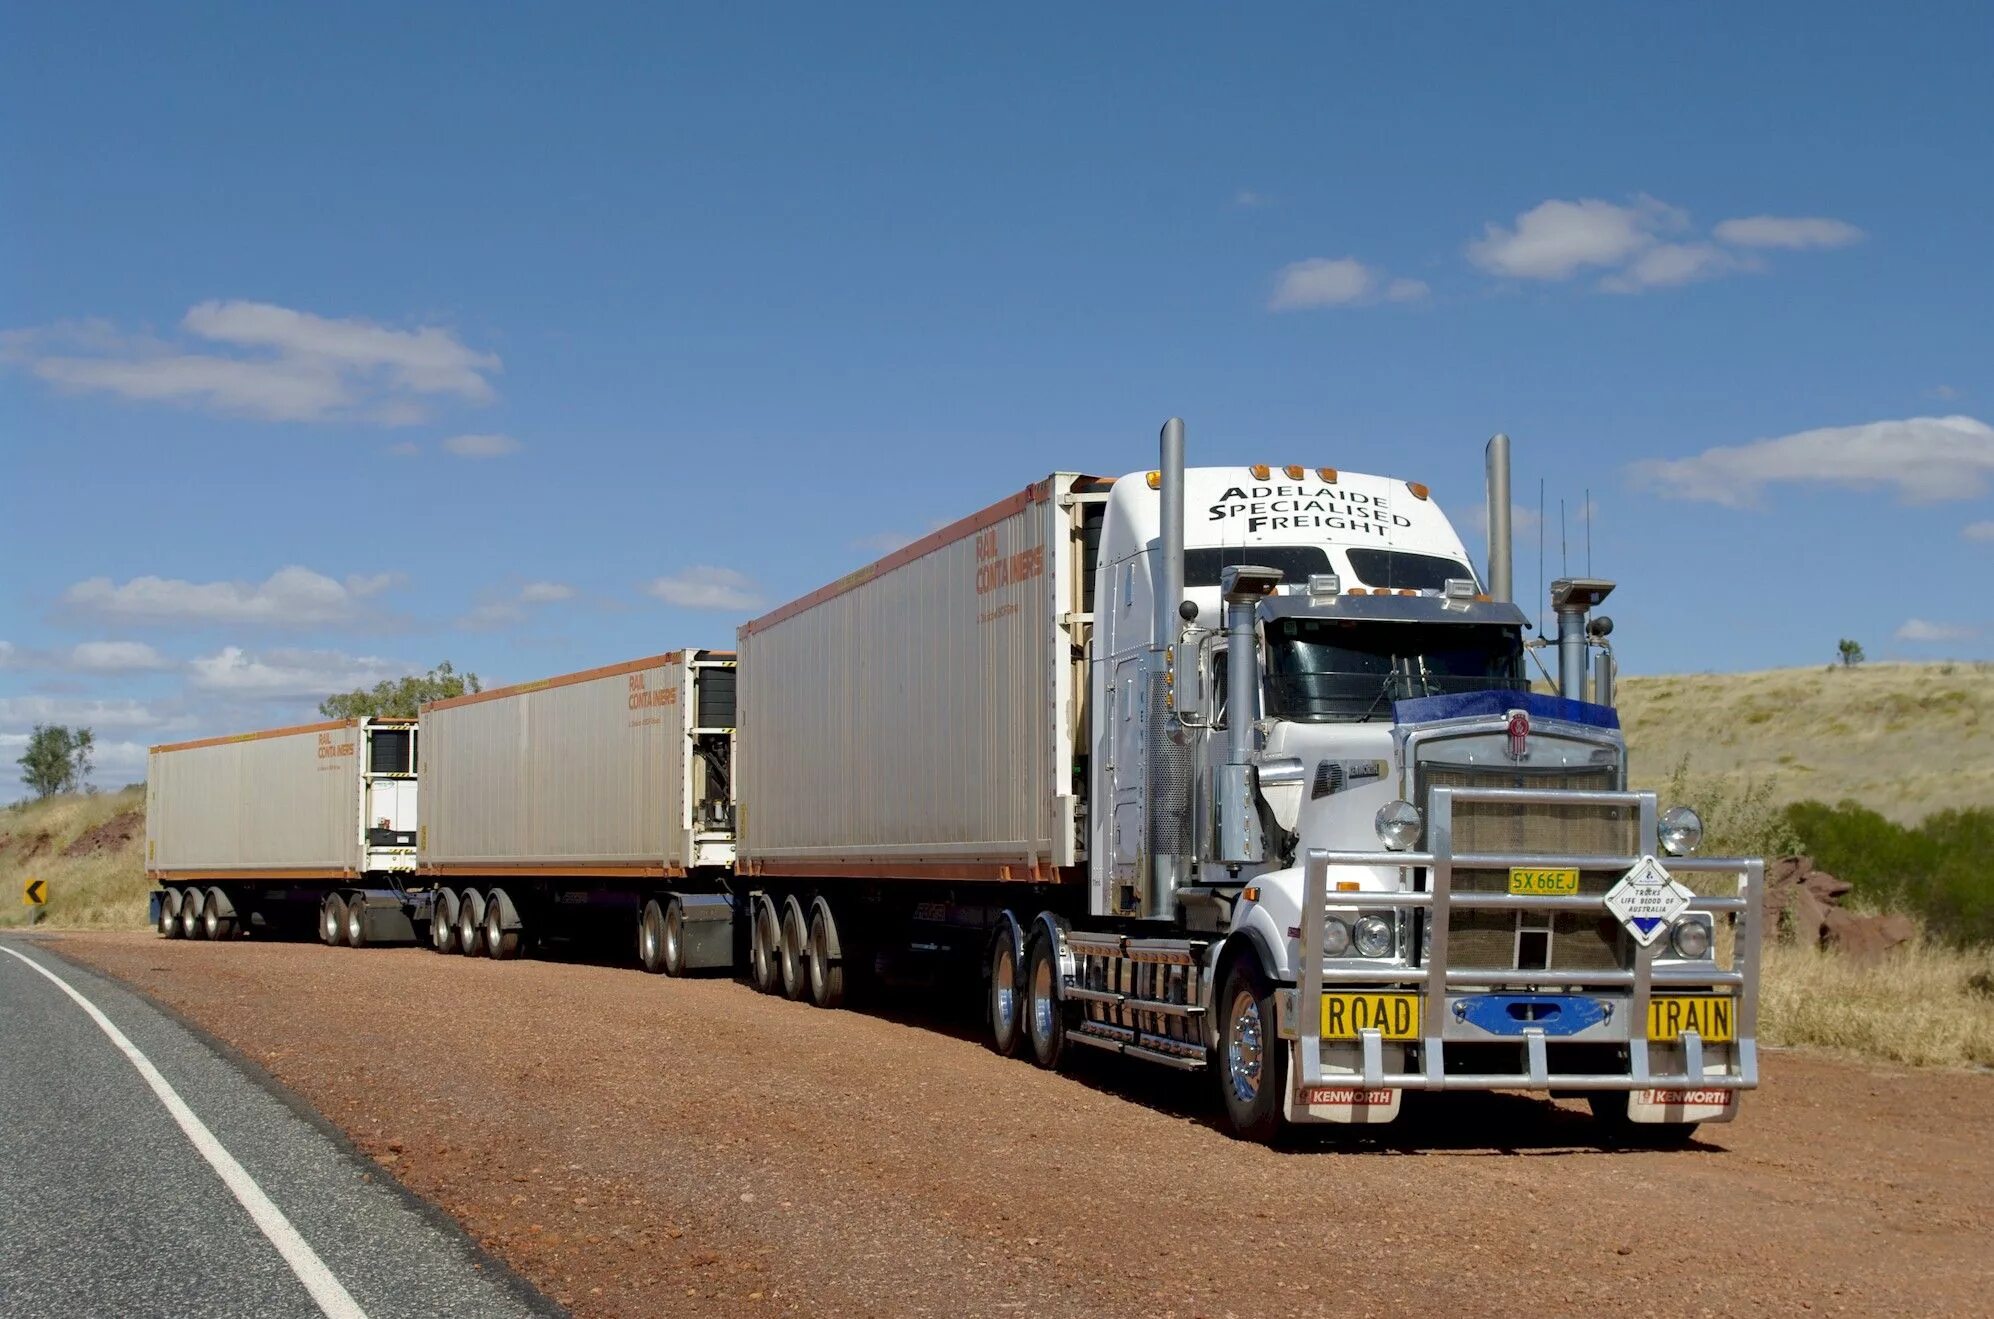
[[0, 938, 558, 1319]]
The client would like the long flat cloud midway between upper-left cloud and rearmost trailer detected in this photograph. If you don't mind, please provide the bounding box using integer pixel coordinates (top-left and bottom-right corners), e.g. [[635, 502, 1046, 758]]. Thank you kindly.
[[62, 567, 399, 627]]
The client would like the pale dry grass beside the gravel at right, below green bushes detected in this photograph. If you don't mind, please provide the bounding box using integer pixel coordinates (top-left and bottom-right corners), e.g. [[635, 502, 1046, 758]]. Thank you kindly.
[[1759, 940, 1994, 1068]]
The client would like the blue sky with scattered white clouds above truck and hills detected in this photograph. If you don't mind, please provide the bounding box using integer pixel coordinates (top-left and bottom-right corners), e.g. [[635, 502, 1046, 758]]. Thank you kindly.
[[0, 4, 1994, 798]]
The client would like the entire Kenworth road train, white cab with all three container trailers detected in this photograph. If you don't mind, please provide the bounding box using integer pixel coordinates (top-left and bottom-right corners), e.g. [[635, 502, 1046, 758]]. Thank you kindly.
[[148, 421, 1763, 1141]]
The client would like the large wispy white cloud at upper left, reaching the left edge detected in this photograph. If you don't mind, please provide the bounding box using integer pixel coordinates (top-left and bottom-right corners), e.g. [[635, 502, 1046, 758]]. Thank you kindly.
[[0, 301, 500, 425]]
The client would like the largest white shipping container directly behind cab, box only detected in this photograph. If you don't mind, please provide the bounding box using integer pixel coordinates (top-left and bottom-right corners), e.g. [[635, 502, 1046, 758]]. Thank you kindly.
[[738, 473, 1107, 882]]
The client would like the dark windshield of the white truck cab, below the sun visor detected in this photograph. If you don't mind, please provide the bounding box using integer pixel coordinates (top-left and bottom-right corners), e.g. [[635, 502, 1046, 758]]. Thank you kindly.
[[1266, 619, 1529, 722]]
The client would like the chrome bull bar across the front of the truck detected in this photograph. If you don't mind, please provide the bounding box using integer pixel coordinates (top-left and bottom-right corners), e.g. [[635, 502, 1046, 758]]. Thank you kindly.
[[1294, 786, 1765, 1092]]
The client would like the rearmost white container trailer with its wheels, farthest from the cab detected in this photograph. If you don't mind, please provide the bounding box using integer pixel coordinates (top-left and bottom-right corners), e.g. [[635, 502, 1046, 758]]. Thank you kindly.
[[146, 718, 419, 944]]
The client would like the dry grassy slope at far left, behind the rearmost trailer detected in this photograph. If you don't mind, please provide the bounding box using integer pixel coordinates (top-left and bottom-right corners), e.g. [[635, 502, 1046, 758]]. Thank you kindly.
[[0, 788, 152, 930]]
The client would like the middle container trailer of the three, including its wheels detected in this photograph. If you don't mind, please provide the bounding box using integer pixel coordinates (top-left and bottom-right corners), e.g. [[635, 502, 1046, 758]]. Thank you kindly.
[[417, 651, 734, 976]]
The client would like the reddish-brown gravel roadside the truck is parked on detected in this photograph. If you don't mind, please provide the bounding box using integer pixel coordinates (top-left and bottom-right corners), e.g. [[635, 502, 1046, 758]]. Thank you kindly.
[[52, 934, 1994, 1319]]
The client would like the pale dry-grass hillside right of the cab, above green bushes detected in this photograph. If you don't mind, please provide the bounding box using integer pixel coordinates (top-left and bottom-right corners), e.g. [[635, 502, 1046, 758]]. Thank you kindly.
[[1617, 662, 1994, 824]]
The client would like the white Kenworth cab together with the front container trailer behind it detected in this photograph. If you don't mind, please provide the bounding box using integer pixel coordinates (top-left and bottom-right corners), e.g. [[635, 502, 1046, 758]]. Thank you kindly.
[[736, 421, 1763, 1139]]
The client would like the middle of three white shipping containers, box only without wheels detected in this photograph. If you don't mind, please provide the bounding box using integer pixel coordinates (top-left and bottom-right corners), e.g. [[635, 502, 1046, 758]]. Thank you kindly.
[[419, 651, 734, 880]]
